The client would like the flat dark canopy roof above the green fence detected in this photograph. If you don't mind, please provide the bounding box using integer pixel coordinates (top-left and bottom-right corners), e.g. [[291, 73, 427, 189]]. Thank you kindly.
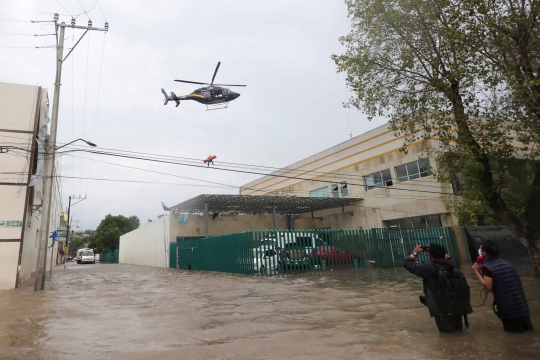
[[170, 195, 363, 215]]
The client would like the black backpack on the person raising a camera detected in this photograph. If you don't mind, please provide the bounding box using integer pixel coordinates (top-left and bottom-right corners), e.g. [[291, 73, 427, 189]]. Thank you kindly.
[[437, 266, 472, 315]]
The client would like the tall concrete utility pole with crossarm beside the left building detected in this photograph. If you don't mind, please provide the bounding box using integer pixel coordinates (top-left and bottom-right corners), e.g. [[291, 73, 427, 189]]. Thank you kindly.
[[34, 14, 109, 291]]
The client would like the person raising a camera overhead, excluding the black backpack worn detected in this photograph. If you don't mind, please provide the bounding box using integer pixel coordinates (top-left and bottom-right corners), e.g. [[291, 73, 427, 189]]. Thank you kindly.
[[403, 244, 472, 333]]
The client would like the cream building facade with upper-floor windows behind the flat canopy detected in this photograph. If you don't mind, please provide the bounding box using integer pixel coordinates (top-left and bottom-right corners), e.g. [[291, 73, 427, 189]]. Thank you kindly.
[[240, 125, 458, 228]]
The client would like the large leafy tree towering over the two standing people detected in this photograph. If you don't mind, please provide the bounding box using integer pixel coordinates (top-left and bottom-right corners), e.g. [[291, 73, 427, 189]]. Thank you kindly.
[[332, 0, 540, 269]]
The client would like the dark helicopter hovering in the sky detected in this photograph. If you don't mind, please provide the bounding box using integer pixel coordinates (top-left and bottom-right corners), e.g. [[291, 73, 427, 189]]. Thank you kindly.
[[161, 61, 247, 110]]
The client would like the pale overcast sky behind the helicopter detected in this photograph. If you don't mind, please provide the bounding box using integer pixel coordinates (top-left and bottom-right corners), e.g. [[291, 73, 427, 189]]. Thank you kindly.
[[0, 0, 384, 230]]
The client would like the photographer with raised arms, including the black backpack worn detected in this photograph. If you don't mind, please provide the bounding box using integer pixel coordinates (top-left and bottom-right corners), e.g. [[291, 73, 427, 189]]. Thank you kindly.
[[403, 244, 472, 333]]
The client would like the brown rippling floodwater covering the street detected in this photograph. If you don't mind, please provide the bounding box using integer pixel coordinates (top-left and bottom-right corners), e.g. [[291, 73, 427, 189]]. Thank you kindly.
[[0, 263, 540, 360]]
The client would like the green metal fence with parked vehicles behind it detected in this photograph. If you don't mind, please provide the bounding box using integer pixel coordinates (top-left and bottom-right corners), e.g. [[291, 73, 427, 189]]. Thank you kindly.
[[175, 228, 458, 275]]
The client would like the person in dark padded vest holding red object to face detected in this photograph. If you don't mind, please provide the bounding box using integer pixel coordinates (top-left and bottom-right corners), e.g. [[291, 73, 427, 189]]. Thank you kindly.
[[473, 240, 534, 332]]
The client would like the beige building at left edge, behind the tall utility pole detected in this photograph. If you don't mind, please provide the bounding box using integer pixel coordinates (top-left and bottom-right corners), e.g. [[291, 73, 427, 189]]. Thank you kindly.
[[0, 83, 61, 289]]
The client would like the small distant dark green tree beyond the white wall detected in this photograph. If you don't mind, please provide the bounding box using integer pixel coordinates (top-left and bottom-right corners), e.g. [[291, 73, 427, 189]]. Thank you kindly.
[[92, 214, 140, 252]]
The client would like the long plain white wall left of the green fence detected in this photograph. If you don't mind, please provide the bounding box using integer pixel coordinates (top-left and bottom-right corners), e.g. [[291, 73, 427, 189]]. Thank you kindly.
[[118, 216, 170, 267]]
